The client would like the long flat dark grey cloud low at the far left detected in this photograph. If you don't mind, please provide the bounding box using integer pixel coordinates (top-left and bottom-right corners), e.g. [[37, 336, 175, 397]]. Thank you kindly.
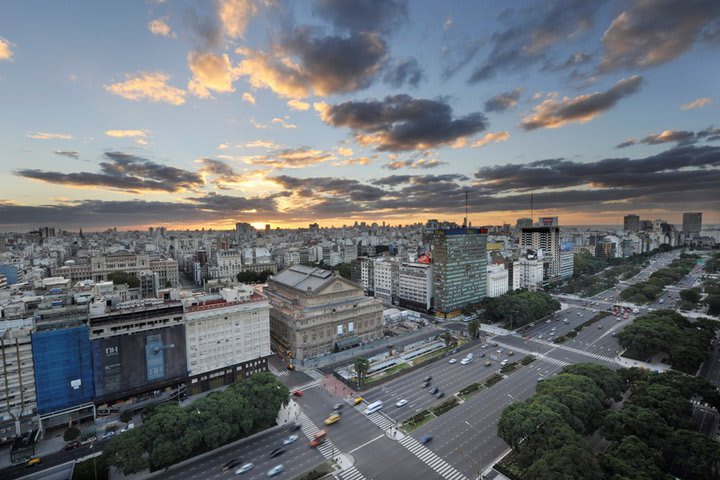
[[15, 152, 204, 192]]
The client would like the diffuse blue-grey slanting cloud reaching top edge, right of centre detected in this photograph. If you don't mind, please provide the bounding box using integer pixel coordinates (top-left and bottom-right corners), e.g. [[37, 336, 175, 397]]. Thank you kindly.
[[468, 0, 604, 83]]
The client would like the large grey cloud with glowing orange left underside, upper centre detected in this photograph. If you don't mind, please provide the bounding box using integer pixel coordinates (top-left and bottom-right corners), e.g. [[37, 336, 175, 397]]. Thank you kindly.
[[235, 27, 386, 98]]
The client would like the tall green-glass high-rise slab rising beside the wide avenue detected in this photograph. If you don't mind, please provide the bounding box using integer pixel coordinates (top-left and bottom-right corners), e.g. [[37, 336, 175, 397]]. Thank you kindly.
[[430, 228, 487, 318]]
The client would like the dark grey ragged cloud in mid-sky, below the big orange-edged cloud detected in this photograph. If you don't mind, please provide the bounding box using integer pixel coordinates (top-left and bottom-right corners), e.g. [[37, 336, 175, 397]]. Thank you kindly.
[[320, 95, 487, 151]]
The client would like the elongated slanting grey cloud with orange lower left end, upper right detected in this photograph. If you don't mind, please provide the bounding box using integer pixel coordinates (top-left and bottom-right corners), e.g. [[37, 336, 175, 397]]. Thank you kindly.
[[520, 75, 642, 130]]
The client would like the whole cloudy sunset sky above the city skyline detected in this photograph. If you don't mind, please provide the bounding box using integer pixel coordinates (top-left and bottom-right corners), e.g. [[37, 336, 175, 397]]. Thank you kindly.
[[0, 0, 720, 231]]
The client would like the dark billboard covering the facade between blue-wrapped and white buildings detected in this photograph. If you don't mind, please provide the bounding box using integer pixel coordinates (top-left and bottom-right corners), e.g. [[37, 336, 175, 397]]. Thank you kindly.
[[91, 325, 187, 403]]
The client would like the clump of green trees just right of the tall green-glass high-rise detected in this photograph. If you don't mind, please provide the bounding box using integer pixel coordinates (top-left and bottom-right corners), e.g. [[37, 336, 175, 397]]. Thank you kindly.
[[485, 290, 560, 328]]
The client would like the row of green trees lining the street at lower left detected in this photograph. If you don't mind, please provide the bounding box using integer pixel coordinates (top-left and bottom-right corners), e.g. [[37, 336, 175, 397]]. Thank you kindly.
[[103, 372, 289, 475]]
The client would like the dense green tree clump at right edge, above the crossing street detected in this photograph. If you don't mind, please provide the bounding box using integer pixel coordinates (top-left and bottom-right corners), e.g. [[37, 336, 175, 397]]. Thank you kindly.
[[618, 310, 717, 374]]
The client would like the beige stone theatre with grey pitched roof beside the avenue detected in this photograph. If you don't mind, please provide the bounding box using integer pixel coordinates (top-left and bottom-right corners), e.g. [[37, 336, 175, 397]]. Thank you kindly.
[[264, 265, 383, 360]]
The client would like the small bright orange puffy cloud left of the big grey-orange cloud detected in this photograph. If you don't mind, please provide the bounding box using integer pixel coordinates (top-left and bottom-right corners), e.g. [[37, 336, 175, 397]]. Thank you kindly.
[[188, 52, 235, 98]]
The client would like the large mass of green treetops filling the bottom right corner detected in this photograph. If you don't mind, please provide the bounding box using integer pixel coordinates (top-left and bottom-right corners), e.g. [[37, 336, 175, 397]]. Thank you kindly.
[[498, 364, 720, 480]]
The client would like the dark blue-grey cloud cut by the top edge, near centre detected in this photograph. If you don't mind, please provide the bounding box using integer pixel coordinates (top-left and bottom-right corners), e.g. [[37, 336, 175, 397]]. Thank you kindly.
[[313, 0, 407, 32]]
